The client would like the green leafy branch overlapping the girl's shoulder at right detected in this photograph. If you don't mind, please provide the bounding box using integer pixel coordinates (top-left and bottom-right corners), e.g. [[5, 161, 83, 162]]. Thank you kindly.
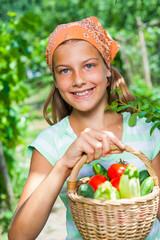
[[105, 80, 160, 134]]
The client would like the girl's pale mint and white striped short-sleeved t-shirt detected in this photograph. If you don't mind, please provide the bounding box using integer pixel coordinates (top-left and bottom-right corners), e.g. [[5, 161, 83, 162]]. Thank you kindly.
[[29, 112, 160, 240]]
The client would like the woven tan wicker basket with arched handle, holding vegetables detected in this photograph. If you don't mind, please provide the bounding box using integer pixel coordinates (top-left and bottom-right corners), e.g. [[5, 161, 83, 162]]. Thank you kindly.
[[67, 145, 159, 240]]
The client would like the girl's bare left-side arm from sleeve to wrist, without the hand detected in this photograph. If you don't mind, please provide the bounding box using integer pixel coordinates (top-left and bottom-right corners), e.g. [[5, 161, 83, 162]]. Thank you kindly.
[[8, 150, 68, 240]]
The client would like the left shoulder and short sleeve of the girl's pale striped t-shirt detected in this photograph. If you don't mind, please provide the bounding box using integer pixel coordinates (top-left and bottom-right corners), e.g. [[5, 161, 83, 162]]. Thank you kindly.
[[28, 117, 76, 165]]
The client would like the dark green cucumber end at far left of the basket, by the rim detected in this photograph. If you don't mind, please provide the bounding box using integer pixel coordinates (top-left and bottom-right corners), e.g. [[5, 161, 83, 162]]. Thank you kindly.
[[78, 183, 95, 198]]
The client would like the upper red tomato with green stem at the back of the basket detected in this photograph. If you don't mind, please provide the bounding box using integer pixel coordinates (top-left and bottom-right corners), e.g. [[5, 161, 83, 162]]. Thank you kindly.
[[108, 163, 127, 179]]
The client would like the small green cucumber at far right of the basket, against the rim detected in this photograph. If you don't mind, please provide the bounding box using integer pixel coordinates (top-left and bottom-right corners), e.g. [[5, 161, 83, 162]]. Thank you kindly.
[[140, 177, 154, 196]]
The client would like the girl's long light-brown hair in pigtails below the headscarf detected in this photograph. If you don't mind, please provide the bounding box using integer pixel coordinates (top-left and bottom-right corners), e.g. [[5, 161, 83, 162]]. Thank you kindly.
[[43, 66, 135, 125]]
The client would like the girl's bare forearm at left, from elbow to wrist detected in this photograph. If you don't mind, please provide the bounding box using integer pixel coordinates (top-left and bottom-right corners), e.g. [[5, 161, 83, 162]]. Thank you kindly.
[[9, 159, 68, 240]]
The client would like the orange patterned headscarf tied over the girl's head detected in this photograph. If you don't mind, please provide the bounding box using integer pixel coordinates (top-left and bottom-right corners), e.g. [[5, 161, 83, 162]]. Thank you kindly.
[[46, 17, 119, 73]]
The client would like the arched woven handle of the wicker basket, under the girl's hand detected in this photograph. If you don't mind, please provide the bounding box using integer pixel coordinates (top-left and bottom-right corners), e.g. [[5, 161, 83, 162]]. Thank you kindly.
[[67, 144, 158, 191]]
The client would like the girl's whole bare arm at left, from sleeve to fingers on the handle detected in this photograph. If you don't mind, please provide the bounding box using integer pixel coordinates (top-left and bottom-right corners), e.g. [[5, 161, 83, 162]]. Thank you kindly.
[[8, 129, 124, 240]]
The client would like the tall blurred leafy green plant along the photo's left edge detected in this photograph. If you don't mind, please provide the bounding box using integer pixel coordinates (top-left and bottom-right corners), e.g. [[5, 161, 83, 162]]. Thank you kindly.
[[0, 12, 41, 210]]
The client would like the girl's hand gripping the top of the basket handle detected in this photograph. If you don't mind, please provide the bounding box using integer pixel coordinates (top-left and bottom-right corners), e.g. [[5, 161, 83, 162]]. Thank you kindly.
[[60, 128, 125, 169]]
